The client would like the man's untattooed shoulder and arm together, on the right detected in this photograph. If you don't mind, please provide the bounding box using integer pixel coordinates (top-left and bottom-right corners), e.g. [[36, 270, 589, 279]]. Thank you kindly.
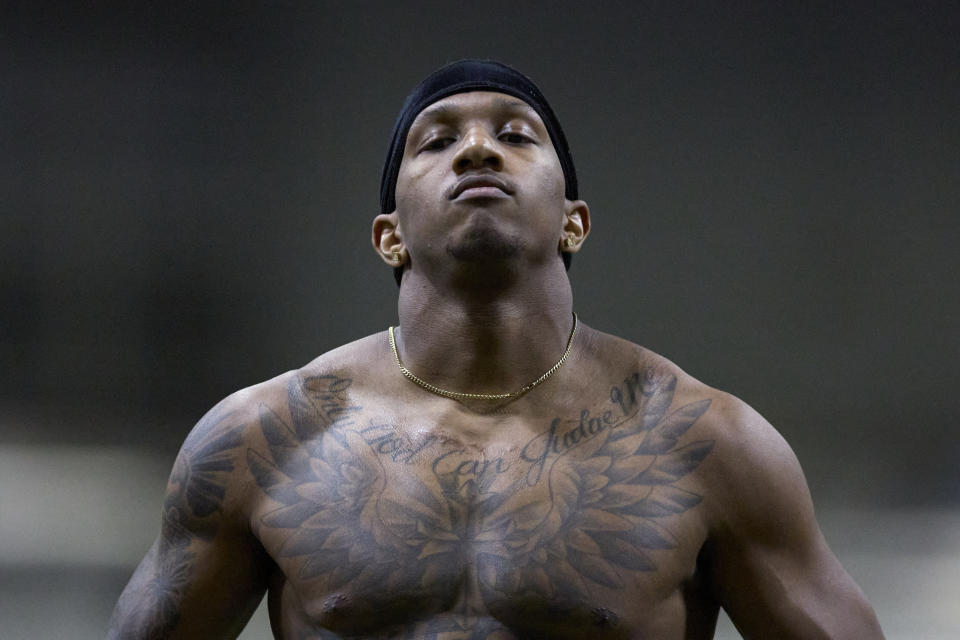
[[592, 332, 883, 638]]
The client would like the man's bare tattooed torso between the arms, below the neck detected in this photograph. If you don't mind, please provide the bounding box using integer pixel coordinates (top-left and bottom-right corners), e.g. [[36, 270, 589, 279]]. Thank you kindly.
[[236, 332, 717, 640]]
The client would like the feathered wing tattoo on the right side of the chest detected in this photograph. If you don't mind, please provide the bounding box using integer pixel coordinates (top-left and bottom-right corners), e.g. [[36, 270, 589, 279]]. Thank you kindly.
[[478, 375, 714, 606]]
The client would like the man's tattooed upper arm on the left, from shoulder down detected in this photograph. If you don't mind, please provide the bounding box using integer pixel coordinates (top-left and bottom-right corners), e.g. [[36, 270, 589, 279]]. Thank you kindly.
[[107, 399, 268, 640]]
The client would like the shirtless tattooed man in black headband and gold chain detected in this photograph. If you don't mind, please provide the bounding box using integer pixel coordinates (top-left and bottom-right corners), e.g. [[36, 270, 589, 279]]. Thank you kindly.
[[109, 61, 882, 640]]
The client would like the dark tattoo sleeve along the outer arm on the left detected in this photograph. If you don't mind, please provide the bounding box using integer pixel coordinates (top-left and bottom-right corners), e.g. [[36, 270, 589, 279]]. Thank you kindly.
[[108, 408, 243, 640]]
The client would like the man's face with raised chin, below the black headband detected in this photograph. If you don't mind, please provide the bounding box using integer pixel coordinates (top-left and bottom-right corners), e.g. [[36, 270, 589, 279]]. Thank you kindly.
[[396, 91, 569, 276]]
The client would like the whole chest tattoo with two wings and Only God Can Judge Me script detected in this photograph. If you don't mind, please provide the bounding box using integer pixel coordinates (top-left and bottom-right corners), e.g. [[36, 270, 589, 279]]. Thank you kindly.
[[248, 374, 713, 640]]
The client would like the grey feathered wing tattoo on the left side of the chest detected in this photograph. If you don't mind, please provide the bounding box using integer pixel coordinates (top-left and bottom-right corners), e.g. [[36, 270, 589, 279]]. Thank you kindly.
[[247, 376, 406, 589]]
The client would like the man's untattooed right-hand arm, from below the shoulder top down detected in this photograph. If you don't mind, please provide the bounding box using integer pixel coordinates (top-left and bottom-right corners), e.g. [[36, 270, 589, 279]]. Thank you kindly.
[[706, 399, 883, 640]]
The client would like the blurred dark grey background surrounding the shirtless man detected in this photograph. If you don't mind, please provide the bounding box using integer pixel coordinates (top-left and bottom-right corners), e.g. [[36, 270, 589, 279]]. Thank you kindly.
[[0, 0, 960, 640]]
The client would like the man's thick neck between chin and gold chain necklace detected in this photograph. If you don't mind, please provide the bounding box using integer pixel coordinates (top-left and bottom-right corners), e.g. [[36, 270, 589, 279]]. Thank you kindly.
[[397, 266, 573, 393]]
